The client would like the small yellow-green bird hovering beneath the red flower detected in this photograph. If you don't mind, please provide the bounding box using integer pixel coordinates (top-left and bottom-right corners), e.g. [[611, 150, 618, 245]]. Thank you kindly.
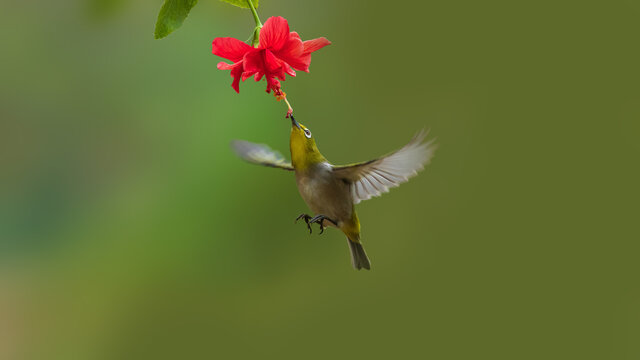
[[231, 115, 437, 270]]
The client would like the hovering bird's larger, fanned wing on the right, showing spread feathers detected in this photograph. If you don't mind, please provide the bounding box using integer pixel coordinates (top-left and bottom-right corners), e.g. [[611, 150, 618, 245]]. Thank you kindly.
[[333, 130, 436, 204]]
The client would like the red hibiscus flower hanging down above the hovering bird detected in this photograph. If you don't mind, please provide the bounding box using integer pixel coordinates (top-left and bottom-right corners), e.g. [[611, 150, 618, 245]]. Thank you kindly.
[[213, 16, 331, 94]]
